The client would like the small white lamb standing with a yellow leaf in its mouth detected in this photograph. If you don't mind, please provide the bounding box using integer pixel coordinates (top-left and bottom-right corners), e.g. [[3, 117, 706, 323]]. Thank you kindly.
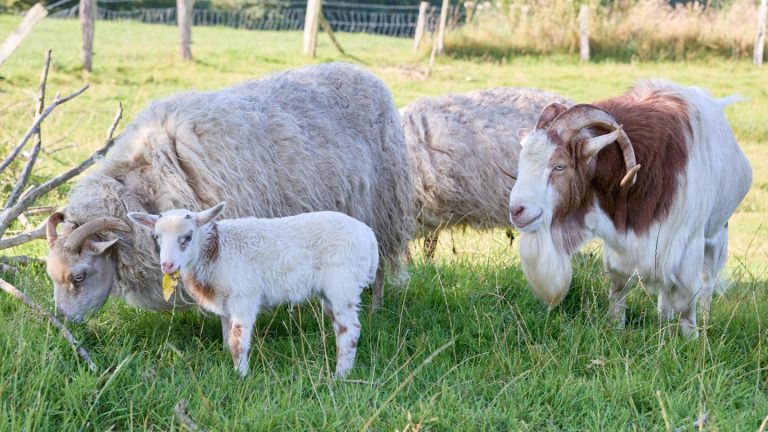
[[128, 203, 379, 377]]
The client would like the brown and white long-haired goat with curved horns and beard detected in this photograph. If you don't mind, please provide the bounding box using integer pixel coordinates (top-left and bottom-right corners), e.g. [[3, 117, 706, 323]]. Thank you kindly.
[[509, 81, 752, 336]]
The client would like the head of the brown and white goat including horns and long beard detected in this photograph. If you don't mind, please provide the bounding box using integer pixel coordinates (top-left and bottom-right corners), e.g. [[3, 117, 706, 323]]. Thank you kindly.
[[509, 104, 640, 306]]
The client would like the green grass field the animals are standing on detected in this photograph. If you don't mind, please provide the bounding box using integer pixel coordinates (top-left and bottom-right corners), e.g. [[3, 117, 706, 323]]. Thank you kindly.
[[0, 16, 768, 431]]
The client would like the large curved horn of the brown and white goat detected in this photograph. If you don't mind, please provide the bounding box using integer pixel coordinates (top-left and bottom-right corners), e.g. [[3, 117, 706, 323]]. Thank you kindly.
[[552, 104, 640, 187]]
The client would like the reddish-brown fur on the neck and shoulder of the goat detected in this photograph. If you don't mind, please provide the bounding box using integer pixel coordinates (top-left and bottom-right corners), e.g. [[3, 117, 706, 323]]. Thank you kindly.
[[553, 91, 692, 238]]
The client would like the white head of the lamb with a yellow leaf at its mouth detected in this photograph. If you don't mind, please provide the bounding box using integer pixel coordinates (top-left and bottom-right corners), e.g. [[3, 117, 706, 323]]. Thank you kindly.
[[128, 202, 226, 274]]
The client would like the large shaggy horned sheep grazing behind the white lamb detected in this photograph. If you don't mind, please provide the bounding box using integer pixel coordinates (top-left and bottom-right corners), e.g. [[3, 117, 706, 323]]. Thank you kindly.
[[48, 63, 415, 320]]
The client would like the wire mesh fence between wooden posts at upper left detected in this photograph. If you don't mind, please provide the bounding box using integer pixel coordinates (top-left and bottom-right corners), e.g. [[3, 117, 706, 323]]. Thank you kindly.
[[48, 0, 465, 37]]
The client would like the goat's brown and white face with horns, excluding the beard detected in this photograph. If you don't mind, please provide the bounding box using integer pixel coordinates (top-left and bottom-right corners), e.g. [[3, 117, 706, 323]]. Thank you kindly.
[[509, 103, 640, 232]]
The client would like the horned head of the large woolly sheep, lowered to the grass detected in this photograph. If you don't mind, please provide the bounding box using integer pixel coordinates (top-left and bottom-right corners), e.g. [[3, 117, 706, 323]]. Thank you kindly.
[[46, 212, 130, 321]]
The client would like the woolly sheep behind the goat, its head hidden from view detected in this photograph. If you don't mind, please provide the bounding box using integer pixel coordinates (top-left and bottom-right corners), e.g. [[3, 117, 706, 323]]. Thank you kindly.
[[400, 88, 572, 259]]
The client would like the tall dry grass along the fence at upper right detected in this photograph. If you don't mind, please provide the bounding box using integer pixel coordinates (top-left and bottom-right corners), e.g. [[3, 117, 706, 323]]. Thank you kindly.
[[446, 0, 758, 60]]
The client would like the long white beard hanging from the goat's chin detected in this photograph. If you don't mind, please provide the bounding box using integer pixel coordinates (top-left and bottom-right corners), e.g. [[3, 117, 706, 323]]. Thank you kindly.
[[519, 227, 573, 309]]
